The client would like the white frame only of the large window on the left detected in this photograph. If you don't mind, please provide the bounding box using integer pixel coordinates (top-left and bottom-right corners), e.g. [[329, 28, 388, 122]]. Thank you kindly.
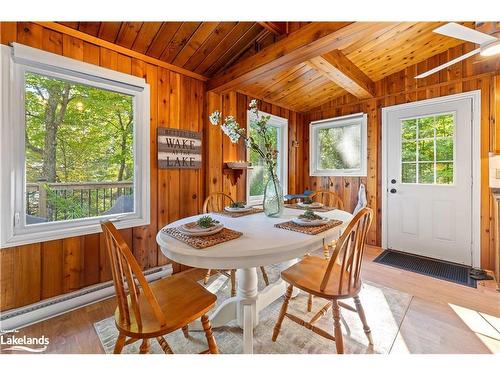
[[0, 43, 150, 247]]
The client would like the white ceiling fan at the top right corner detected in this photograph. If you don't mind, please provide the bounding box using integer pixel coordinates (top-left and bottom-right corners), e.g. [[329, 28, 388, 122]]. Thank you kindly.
[[415, 22, 500, 78]]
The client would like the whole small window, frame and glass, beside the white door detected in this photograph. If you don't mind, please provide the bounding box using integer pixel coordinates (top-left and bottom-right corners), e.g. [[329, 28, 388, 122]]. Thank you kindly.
[[309, 113, 367, 176]]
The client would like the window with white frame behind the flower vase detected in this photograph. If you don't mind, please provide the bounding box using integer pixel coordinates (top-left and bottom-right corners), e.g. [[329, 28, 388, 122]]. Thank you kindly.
[[247, 111, 288, 205]]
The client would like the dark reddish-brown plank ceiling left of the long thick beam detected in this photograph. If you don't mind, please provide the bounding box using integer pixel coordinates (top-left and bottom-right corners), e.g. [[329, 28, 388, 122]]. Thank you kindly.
[[59, 22, 272, 77]]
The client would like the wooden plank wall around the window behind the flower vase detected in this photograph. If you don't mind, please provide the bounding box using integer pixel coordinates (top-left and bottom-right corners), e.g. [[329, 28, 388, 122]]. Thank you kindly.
[[205, 92, 305, 201]]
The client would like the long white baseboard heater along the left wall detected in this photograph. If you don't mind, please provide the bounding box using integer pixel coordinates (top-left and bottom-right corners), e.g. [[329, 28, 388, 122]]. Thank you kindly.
[[0, 264, 172, 332]]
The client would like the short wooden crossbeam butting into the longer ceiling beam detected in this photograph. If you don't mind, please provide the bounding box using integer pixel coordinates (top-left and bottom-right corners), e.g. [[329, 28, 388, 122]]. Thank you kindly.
[[308, 50, 375, 99]]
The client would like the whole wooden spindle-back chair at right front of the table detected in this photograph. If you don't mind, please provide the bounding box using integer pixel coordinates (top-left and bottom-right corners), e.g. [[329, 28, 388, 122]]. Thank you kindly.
[[272, 208, 373, 354]]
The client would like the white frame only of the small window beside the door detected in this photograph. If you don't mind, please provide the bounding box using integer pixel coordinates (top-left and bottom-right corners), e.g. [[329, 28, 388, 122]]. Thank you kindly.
[[309, 113, 368, 177]]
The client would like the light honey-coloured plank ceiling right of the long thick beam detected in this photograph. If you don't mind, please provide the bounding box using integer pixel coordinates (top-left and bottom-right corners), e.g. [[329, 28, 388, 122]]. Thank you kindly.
[[232, 22, 474, 112]]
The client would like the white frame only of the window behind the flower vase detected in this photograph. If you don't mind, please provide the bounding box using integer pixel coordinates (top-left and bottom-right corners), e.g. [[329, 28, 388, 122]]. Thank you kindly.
[[246, 111, 288, 206]]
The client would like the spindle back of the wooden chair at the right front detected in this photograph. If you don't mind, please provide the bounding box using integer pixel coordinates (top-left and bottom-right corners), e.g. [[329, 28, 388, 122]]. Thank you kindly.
[[320, 207, 373, 294]]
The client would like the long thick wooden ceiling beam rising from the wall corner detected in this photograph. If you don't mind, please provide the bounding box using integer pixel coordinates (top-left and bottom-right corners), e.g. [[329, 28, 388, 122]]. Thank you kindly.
[[208, 22, 394, 92]]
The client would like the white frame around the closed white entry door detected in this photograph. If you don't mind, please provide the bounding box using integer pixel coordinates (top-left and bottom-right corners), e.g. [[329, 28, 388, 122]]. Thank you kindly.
[[382, 90, 481, 268]]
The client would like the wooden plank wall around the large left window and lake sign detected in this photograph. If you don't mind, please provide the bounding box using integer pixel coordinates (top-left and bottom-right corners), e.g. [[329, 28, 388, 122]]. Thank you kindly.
[[0, 22, 205, 310]]
